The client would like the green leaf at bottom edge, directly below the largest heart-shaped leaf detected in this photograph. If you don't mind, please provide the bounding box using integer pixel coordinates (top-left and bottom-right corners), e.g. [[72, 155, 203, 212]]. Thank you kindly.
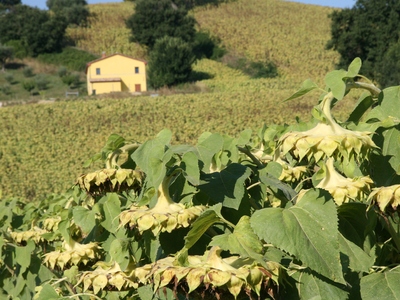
[[291, 271, 348, 300]]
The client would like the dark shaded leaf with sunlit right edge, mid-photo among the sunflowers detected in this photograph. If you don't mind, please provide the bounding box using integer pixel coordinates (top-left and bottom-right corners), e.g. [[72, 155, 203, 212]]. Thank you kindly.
[[198, 163, 251, 209]]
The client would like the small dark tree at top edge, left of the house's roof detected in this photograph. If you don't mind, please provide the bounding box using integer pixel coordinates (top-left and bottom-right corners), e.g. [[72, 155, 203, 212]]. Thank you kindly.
[[46, 0, 90, 26]]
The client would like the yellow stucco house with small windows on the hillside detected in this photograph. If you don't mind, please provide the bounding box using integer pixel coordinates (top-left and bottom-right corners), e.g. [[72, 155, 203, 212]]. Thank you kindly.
[[86, 53, 147, 95]]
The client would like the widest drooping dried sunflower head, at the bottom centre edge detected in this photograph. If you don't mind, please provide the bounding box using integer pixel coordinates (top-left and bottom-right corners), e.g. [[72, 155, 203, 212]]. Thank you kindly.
[[138, 246, 277, 299]]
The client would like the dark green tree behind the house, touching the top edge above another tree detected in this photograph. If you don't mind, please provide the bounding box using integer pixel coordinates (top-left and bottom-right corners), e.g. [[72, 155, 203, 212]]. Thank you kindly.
[[126, 0, 196, 49]]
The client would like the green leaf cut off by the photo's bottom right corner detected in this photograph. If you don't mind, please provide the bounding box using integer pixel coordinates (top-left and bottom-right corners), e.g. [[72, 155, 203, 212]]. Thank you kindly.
[[360, 267, 400, 300]]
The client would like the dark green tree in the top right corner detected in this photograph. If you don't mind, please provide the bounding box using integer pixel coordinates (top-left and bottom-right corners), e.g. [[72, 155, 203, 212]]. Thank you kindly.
[[327, 0, 400, 85]]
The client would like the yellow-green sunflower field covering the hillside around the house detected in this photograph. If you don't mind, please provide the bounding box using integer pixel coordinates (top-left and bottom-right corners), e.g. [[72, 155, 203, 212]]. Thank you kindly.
[[0, 0, 356, 199]]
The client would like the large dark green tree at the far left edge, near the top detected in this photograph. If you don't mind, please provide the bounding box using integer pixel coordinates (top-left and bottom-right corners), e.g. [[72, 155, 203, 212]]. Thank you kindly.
[[0, 5, 67, 57]]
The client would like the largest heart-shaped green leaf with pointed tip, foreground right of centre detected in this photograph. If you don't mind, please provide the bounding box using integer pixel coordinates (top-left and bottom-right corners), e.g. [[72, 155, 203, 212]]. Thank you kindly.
[[250, 190, 344, 283]]
